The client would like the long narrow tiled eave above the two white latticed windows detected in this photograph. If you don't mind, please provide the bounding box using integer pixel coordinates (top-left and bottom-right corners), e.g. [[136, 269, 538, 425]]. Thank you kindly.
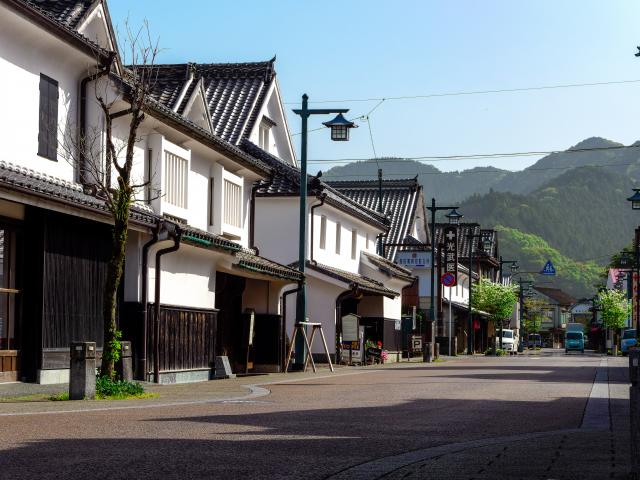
[[111, 72, 271, 176]]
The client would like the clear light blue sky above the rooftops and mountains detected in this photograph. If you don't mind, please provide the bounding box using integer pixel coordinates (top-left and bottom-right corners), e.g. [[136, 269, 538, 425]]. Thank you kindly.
[[108, 0, 640, 173]]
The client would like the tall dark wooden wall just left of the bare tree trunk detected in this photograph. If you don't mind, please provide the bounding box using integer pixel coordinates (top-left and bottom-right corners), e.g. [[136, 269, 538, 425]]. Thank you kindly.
[[21, 207, 111, 381]]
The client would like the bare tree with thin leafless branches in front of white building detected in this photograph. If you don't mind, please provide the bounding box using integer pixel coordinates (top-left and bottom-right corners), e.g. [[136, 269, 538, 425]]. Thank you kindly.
[[62, 22, 159, 378]]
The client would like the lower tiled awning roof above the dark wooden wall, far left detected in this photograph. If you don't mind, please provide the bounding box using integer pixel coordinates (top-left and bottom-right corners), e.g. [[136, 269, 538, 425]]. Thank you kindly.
[[0, 161, 156, 225]]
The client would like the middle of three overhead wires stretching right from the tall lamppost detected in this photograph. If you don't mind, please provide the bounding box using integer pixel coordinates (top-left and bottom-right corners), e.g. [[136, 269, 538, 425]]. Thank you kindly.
[[308, 144, 640, 164]]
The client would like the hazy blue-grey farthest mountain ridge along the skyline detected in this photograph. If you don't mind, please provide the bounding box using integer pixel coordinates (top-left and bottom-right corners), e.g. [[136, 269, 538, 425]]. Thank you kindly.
[[324, 137, 640, 203]]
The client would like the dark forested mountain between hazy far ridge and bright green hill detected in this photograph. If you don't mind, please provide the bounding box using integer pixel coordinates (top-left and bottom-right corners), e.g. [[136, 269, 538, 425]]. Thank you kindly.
[[460, 167, 640, 264]]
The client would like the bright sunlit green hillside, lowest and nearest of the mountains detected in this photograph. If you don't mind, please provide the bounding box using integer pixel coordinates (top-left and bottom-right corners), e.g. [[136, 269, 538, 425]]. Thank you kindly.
[[496, 225, 602, 298]]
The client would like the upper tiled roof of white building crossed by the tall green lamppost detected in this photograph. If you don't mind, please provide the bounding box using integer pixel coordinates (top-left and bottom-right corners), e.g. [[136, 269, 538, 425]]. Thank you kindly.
[[240, 140, 388, 230]]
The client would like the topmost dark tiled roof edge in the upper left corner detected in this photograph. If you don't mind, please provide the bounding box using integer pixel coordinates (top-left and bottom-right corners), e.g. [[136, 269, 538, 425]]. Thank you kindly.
[[0, 0, 111, 62]]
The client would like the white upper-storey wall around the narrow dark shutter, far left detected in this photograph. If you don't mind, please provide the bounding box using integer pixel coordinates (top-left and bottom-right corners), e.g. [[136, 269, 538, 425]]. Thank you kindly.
[[0, 5, 95, 181]]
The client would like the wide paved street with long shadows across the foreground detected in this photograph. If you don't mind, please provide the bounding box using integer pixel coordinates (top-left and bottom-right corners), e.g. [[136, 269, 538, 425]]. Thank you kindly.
[[0, 351, 629, 480]]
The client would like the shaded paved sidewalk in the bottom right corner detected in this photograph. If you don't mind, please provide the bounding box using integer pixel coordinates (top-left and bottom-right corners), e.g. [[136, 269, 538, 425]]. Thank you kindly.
[[331, 358, 630, 480]]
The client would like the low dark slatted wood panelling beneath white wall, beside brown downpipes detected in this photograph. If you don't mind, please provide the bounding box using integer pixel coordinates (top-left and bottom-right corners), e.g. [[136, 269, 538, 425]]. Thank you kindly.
[[147, 303, 218, 372]]
